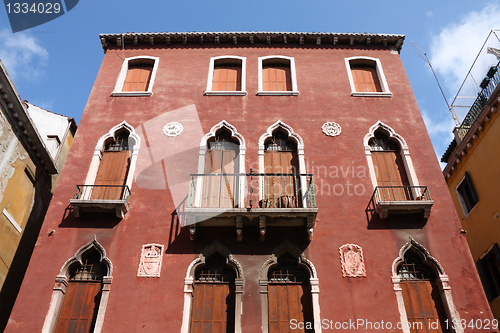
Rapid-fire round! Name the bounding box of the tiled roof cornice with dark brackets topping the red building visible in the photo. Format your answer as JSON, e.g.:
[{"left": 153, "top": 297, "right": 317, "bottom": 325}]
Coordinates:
[{"left": 99, "top": 31, "right": 405, "bottom": 52}]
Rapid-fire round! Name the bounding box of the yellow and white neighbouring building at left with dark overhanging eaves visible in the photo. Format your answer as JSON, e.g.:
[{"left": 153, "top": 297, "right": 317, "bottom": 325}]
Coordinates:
[{"left": 0, "top": 61, "right": 76, "bottom": 331}]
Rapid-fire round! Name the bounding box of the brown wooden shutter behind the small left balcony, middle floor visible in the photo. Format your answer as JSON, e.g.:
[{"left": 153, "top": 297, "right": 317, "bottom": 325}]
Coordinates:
[{"left": 92, "top": 150, "right": 130, "bottom": 200}]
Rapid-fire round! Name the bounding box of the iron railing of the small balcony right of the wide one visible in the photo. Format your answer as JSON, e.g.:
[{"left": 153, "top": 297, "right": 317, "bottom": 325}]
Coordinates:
[{"left": 373, "top": 186, "right": 432, "bottom": 203}]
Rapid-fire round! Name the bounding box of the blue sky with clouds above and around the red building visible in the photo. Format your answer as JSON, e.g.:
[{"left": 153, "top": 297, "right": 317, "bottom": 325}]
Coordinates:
[{"left": 0, "top": 0, "right": 500, "bottom": 162}]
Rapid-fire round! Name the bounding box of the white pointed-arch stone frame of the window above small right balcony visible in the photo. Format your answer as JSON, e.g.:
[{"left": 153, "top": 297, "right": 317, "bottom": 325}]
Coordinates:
[{"left": 363, "top": 120, "right": 419, "bottom": 190}]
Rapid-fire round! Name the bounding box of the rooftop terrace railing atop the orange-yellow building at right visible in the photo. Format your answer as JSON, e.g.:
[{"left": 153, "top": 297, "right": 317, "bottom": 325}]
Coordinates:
[{"left": 455, "top": 62, "right": 500, "bottom": 140}]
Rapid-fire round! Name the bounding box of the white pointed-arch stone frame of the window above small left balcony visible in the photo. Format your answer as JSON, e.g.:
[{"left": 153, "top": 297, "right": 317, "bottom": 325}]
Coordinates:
[{"left": 84, "top": 121, "right": 141, "bottom": 195}]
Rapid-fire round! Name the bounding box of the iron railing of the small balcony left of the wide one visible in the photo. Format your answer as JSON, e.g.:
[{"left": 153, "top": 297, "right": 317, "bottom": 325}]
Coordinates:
[{"left": 72, "top": 185, "right": 130, "bottom": 203}]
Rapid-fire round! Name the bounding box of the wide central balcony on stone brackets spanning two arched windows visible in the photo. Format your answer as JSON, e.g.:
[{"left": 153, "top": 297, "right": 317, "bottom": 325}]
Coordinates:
[{"left": 186, "top": 172, "right": 318, "bottom": 240}]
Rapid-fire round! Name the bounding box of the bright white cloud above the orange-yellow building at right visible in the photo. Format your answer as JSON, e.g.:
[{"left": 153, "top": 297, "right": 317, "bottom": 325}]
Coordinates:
[{"left": 430, "top": 3, "right": 500, "bottom": 94}]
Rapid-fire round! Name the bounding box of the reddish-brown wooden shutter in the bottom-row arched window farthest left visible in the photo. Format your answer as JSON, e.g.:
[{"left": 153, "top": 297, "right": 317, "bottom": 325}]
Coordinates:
[{"left": 54, "top": 281, "right": 101, "bottom": 333}]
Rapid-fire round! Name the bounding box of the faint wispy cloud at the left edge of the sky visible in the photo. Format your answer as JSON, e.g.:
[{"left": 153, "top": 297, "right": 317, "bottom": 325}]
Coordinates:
[{"left": 0, "top": 30, "right": 49, "bottom": 79}]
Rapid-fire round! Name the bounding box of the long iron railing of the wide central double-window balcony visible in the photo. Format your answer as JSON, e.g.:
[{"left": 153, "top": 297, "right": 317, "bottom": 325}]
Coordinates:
[{"left": 188, "top": 172, "right": 316, "bottom": 209}]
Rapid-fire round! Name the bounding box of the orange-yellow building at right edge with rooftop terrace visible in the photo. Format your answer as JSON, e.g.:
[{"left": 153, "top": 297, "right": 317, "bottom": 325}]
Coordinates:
[{"left": 441, "top": 46, "right": 500, "bottom": 319}]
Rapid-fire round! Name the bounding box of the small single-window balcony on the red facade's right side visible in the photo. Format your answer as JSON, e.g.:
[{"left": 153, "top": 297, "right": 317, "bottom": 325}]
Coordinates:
[{"left": 371, "top": 186, "right": 434, "bottom": 219}]
